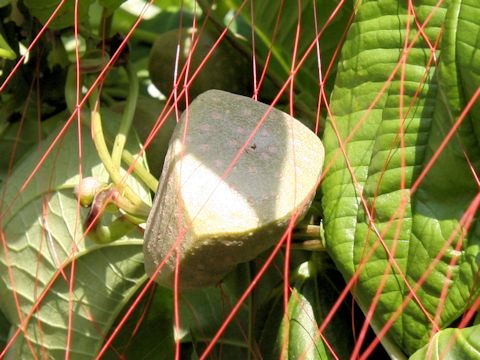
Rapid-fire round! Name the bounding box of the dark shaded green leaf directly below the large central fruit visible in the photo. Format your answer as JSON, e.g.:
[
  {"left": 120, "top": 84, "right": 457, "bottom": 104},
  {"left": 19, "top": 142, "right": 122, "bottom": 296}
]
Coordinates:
[{"left": 103, "top": 266, "right": 250, "bottom": 359}]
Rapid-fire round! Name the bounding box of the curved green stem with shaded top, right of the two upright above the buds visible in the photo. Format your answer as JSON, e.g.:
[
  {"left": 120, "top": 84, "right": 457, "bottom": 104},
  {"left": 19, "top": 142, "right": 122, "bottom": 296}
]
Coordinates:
[{"left": 112, "top": 63, "right": 138, "bottom": 168}]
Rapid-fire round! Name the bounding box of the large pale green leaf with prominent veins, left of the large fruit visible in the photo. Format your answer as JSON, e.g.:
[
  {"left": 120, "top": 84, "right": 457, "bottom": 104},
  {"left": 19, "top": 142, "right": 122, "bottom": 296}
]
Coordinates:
[{"left": 0, "top": 116, "right": 149, "bottom": 359}]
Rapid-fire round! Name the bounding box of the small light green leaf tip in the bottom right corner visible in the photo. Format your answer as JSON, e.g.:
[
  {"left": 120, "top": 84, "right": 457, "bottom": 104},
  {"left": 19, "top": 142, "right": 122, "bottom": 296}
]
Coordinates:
[{"left": 410, "top": 325, "right": 480, "bottom": 360}]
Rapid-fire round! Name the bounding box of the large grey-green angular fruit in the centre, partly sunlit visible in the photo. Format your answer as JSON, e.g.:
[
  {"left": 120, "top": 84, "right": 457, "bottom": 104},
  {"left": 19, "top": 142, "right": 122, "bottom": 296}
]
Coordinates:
[{"left": 144, "top": 90, "right": 324, "bottom": 288}]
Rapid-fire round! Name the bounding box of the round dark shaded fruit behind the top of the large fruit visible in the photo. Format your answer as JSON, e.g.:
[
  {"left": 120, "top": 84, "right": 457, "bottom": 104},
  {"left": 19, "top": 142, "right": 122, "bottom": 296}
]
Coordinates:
[{"left": 148, "top": 28, "right": 252, "bottom": 103}]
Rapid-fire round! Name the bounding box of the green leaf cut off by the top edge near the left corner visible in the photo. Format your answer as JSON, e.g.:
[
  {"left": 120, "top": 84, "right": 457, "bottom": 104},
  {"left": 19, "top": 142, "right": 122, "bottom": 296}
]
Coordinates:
[{"left": 24, "top": 0, "right": 93, "bottom": 30}]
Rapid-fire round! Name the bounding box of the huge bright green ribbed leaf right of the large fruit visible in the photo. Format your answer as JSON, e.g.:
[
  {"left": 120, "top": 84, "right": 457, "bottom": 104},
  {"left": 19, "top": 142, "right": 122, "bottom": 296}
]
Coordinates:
[{"left": 322, "top": 0, "right": 480, "bottom": 354}]
